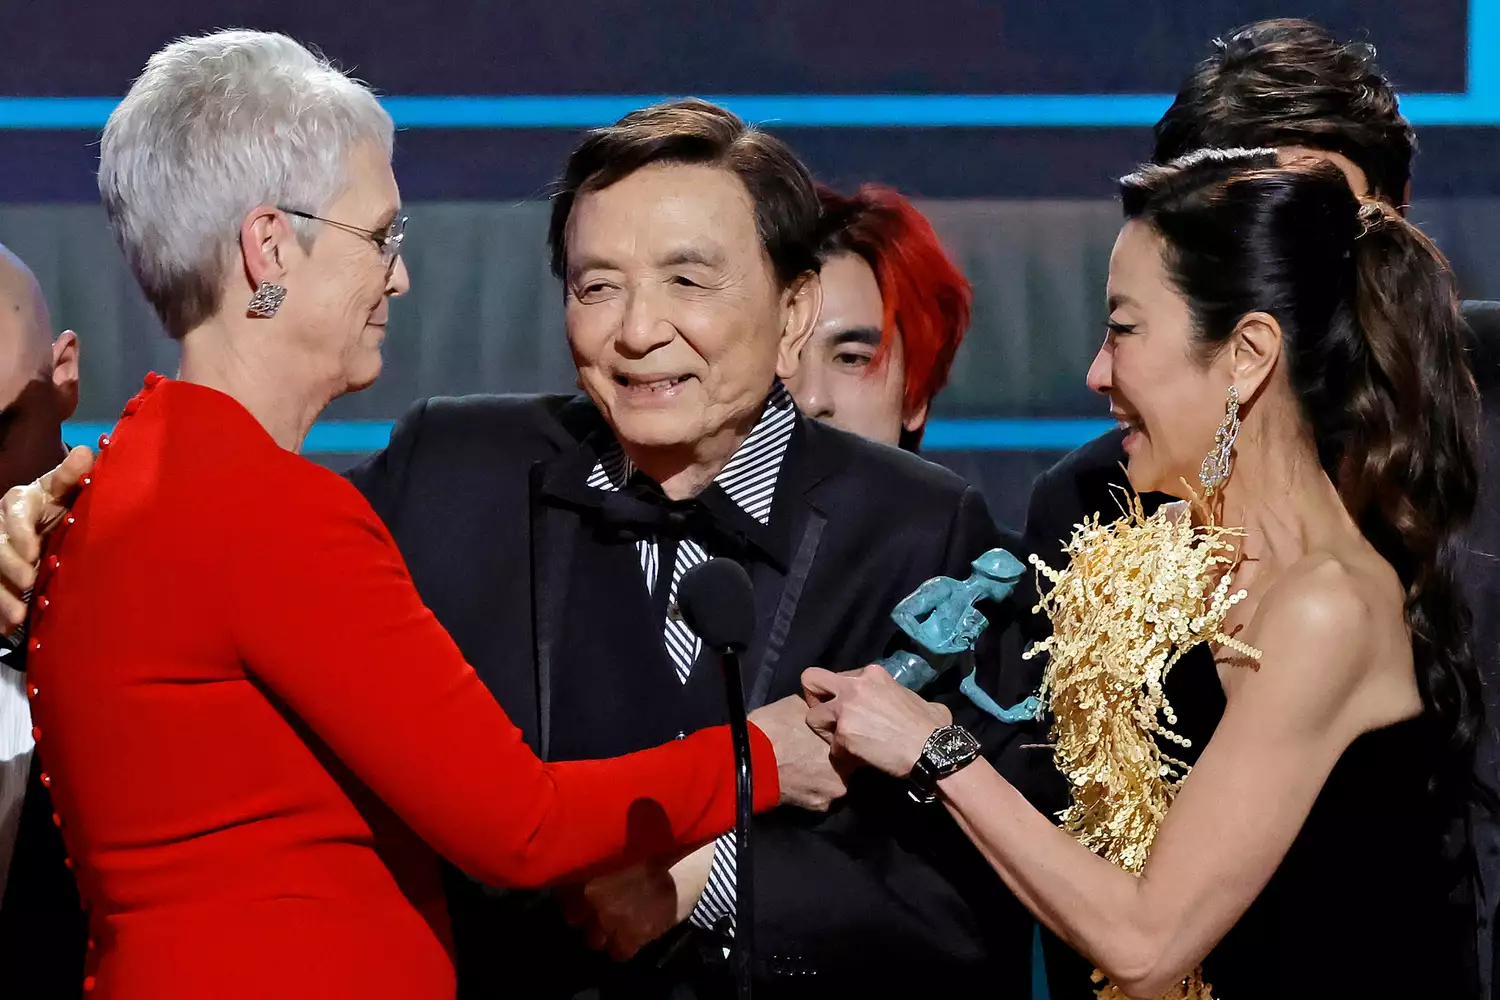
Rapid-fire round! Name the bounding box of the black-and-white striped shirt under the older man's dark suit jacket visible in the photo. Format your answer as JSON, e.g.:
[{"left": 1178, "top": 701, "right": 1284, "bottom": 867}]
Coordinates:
[{"left": 588, "top": 382, "right": 797, "bottom": 930}]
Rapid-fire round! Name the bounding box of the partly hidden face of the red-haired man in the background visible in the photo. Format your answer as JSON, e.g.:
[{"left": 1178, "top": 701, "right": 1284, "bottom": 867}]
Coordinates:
[{"left": 786, "top": 253, "right": 927, "bottom": 445}]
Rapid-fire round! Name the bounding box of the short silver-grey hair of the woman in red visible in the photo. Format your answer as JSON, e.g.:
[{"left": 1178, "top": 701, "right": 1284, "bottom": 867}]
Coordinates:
[{"left": 99, "top": 30, "right": 395, "bottom": 337}]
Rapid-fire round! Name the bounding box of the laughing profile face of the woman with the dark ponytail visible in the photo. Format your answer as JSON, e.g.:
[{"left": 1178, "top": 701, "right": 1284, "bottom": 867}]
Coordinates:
[{"left": 1088, "top": 220, "right": 1233, "bottom": 496}]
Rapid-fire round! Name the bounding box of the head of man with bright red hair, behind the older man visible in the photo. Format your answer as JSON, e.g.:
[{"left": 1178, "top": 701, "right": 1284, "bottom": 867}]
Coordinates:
[{"left": 786, "top": 184, "right": 972, "bottom": 451}]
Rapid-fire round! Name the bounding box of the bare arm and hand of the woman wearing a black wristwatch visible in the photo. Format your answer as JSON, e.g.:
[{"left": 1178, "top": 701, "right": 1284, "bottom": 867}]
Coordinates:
[{"left": 804, "top": 561, "right": 1410, "bottom": 997}]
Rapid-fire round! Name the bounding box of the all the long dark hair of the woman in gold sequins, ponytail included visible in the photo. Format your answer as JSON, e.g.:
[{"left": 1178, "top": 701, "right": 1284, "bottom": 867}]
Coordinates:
[{"left": 1121, "top": 150, "right": 1494, "bottom": 816}]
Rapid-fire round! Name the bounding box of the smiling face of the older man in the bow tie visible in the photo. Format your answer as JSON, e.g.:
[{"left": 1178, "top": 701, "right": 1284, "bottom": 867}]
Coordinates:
[{"left": 564, "top": 163, "right": 818, "bottom": 465}]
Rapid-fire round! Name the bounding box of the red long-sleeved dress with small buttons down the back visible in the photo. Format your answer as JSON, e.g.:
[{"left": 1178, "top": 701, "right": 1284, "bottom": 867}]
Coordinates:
[{"left": 27, "top": 375, "right": 779, "bottom": 1000}]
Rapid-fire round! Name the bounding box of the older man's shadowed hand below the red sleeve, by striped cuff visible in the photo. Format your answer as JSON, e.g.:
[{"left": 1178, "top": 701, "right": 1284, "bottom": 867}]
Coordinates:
[{"left": 566, "top": 843, "right": 714, "bottom": 963}]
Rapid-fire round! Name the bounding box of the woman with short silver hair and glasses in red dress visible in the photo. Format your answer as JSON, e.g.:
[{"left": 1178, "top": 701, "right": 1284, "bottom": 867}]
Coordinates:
[{"left": 27, "top": 31, "right": 779, "bottom": 1000}]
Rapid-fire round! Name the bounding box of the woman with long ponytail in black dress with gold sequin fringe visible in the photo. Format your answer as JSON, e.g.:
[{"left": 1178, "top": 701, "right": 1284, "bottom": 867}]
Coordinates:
[{"left": 804, "top": 150, "right": 1479, "bottom": 1000}]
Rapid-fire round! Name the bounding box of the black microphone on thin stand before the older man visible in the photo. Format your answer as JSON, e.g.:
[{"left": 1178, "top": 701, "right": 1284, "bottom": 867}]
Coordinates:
[{"left": 677, "top": 556, "right": 755, "bottom": 1000}]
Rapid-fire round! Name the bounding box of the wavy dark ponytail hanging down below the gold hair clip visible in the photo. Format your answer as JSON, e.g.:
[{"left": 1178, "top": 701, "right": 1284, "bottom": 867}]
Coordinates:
[{"left": 1335, "top": 201, "right": 1485, "bottom": 815}]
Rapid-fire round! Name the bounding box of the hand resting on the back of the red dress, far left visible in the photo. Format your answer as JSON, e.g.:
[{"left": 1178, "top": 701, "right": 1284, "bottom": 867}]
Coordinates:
[{"left": 0, "top": 445, "right": 93, "bottom": 636}]
